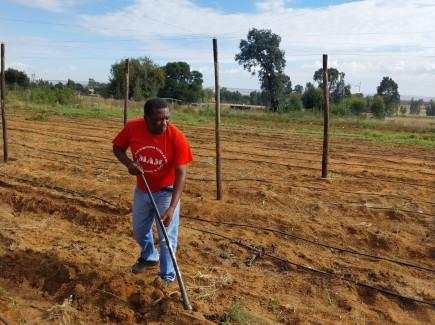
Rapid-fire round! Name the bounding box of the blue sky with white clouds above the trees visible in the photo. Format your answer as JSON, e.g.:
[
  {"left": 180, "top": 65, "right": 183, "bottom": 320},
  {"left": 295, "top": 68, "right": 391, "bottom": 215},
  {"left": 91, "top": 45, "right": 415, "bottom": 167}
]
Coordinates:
[{"left": 0, "top": 0, "right": 435, "bottom": 99}]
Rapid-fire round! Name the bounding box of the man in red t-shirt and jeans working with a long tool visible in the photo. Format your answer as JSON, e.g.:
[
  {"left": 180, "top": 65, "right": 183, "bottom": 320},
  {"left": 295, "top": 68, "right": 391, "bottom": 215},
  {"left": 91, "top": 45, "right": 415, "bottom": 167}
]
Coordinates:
[{"left": 112, "top": 98, "right": 193, "bottom": 286}]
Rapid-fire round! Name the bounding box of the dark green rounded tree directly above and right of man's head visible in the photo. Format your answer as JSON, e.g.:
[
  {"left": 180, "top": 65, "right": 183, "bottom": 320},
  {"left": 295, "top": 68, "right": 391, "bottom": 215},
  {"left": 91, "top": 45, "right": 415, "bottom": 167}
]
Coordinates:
[{"left": 159, "top": 62, "right": 203, "bottom": 102}]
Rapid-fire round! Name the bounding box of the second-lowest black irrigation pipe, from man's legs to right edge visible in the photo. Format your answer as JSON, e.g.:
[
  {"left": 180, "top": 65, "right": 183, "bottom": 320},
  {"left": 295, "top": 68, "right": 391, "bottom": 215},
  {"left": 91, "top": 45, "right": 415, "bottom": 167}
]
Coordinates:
[{"left": 182, "top": 215, "right": 435, "bottom": 273}]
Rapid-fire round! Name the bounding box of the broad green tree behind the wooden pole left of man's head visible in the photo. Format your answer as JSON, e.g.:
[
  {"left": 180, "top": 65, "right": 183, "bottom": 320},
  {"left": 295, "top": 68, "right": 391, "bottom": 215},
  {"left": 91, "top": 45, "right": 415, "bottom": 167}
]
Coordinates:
[{"left": 105, "top": 57, "right": 165, "bottom": 100}]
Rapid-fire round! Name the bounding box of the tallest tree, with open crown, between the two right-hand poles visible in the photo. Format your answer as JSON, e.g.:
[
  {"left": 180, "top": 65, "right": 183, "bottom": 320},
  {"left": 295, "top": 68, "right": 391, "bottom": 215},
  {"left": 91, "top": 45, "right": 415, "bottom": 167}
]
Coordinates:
[{"left": 235, "top": 28, "right": 291, "bottom": 112}]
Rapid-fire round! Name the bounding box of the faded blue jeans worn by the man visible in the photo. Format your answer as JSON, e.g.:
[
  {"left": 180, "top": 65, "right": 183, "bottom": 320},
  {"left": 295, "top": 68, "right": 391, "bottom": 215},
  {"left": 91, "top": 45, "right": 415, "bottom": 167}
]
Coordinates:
[{"left": 132, "top": 186, "right": 180, "bottom": 280}]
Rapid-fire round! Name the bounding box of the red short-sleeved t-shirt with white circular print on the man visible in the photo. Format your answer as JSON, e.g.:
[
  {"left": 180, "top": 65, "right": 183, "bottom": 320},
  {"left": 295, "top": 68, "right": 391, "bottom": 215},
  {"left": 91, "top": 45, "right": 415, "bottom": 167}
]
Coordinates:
[{"left": 112, "top": 117, "right": 193, "bottom": 193}]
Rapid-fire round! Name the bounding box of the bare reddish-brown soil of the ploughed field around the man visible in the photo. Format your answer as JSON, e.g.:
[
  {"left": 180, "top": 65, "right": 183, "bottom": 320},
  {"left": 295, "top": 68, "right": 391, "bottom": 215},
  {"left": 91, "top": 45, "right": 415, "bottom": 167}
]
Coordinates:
[{"left": 0, "top": 109, "right": 435, "bottom": 325}]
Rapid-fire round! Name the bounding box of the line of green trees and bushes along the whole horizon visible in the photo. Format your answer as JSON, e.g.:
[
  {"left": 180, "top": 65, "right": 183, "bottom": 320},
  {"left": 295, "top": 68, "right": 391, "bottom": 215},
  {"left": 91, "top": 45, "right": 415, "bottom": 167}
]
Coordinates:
[{"left": 5, "top": 28, "right": 435, "bottom": 119}]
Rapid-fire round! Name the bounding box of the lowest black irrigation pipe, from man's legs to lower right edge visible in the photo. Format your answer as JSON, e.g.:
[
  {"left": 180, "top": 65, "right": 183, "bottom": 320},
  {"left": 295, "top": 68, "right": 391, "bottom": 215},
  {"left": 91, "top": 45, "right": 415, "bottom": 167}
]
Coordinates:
[{"left": 183, "top": 226, "right": 435, "bottom": 306}]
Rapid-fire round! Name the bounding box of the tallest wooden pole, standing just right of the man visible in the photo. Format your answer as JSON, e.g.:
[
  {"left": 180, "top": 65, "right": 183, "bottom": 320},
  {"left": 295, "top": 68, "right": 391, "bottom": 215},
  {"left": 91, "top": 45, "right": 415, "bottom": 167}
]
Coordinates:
[{"left": 213, "top": 38, "right": 222, "bottom": 200}]
